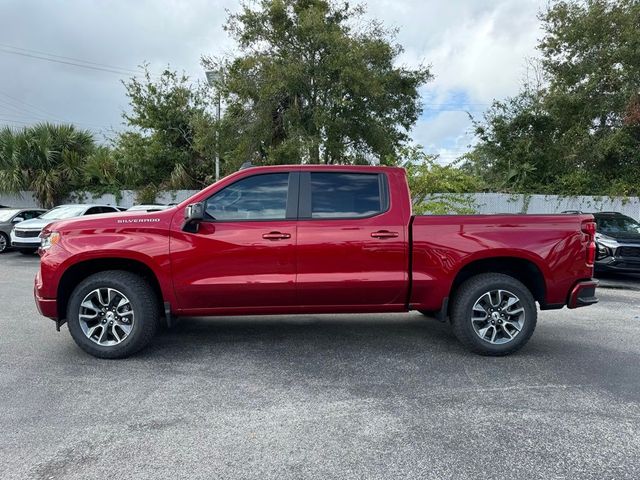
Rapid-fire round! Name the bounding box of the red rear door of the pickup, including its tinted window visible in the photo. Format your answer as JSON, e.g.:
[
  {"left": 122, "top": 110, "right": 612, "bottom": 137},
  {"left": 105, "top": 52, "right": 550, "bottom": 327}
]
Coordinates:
[{"left": 297, "top": 171, "right": 408, "bottom": 311}]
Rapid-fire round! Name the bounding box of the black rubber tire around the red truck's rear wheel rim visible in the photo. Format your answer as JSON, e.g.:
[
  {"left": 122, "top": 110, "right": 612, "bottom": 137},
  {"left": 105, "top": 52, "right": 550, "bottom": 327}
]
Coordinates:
[{"left": 451, "top": 273, "right": 538, "bottom": 356}]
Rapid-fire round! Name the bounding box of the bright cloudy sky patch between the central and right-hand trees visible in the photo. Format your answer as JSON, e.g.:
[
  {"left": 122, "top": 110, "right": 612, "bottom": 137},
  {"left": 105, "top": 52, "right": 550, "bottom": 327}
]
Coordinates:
[{"left": 368, "top": 0, "right": 544, "bottom": 163}]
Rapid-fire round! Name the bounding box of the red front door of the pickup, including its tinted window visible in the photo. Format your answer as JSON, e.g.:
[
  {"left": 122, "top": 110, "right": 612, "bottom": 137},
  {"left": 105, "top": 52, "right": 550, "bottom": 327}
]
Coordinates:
[{"left": 171, "top": 172, "right": 298, "bottom": 314}]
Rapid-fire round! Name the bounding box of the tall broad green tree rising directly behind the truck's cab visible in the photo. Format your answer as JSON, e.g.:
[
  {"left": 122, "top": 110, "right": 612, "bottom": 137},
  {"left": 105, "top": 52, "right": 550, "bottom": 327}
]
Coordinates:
[{"left": 208, "top": 0, "right": 431, "bottom": 167}]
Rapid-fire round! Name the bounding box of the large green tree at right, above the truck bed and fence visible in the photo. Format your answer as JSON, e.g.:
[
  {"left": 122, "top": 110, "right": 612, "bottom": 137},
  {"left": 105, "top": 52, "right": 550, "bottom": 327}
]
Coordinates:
[{"left": 467, "top": 0, "right": 640, "bottom": 195}]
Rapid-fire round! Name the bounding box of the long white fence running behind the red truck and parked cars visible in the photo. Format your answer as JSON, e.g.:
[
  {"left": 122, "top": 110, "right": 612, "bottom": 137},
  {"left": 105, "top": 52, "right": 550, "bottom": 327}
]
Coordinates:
[{"left": 0, "top": 190, "right": 640, "bottom": 219}]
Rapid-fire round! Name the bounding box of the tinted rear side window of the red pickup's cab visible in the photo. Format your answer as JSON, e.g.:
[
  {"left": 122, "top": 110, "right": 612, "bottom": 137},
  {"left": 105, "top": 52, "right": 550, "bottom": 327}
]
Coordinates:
[{"left": 311, "top": 172, "right": 386, "bottom": 218}]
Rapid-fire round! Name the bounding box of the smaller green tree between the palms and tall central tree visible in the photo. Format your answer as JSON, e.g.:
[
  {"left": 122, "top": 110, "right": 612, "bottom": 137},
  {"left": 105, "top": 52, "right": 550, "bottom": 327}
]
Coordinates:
[{"left": 115, "top": 70, "right": 217, "bottom": 189}]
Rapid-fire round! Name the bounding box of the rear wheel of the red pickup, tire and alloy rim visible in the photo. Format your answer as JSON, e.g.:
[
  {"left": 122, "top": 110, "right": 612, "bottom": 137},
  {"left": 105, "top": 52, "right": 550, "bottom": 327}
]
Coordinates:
[{"left": 451, "top": 273, "right": 537, "bottom": 356}]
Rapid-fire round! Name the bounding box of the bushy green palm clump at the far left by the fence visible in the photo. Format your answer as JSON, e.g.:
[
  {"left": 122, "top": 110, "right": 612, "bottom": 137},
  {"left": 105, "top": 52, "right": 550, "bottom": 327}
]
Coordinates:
[{"left": 0, "top": 123, "right": 95, "bottom": 207}]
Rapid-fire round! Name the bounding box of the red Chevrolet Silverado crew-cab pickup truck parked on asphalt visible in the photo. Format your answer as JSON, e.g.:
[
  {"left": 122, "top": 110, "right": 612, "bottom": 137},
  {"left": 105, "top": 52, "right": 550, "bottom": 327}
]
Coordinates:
[{"left": 35, "top": 165, "right": 597, "bottom": 358}]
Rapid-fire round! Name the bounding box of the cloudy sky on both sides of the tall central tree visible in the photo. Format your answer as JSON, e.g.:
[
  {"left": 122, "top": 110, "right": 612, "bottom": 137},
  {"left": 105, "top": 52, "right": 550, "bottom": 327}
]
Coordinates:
[{"left": 0, "top": 0, "right": 545, "bottom": 163}]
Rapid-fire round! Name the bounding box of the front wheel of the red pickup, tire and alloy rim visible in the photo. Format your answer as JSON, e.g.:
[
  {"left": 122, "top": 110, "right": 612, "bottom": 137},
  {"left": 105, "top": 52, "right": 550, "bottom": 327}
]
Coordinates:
[{"left": 67, "top": 270, "right": 160, "bottom": 358}]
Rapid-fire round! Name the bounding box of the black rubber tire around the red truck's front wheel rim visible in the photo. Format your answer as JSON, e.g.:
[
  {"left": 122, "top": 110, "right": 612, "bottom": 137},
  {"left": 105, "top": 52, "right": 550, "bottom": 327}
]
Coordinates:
[{"left": 67, "top": 270, "right": 161, "bottom": 358}]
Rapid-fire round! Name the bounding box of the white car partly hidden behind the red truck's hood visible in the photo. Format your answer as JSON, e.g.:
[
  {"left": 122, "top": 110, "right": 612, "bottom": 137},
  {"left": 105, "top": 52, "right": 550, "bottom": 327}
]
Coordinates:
[{"left": 11, "top": 204, "right": 120, "bottom": 254}]
